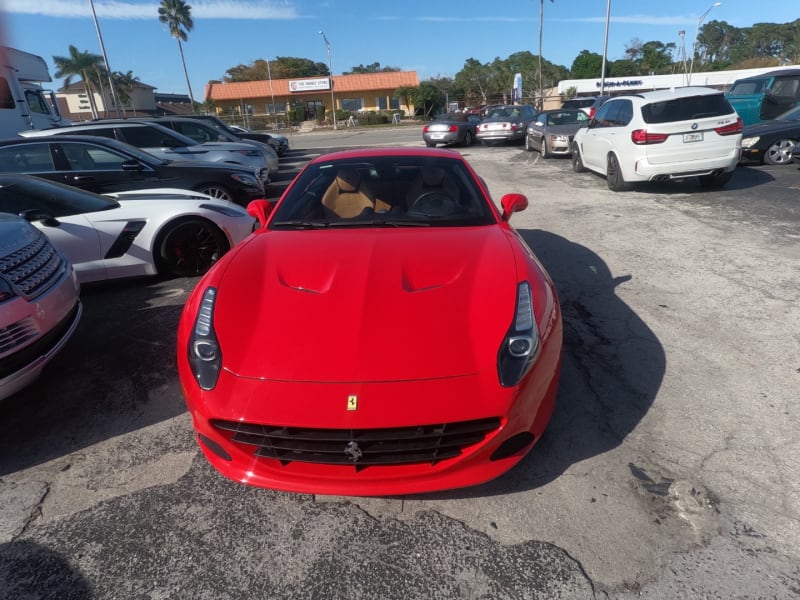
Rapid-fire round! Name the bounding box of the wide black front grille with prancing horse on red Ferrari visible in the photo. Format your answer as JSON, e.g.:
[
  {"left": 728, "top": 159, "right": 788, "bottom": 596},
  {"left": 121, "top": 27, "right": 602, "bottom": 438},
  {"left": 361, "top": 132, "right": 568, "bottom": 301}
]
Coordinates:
[{"left": 211, "top": 417, "right": 500, "bottom": 468}]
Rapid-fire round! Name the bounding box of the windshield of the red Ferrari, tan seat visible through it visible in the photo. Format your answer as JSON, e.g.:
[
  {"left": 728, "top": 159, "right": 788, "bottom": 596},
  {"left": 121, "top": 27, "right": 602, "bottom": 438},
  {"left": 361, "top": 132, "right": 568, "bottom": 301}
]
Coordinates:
[{"left": 270, "top": 156, "right": 495, "bottom": 229}]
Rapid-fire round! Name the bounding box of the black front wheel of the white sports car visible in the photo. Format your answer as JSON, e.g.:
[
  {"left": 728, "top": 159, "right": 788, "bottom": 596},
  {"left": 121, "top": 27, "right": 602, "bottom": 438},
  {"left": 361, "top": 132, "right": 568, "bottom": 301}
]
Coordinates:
[{"left": 153, "top": 217, "right": 230, "bottom": 277}]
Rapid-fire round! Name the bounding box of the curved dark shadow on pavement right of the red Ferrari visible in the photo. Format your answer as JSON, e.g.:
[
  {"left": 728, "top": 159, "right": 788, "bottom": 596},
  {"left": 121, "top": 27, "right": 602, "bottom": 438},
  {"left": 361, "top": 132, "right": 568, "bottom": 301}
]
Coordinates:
[{"left": 406, "top": 229, "right": 668, "bottom": 499}]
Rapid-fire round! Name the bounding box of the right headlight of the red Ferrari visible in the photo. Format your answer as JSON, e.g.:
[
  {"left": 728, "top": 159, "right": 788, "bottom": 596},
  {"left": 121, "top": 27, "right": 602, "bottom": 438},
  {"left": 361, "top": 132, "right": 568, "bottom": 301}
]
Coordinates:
[{"left": 497, "top": 281, "right": 539, "bottom": 387}]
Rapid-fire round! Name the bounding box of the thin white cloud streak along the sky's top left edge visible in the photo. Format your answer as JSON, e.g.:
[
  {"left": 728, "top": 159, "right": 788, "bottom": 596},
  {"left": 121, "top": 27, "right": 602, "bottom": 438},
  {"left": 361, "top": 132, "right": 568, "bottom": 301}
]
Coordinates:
[{"left": 0, "top": 0, "right": 300, "bottom": 20}]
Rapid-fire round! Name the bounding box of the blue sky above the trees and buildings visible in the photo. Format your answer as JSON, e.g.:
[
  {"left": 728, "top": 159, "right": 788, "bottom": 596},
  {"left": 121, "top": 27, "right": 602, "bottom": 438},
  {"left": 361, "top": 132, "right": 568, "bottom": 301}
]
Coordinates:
[{"left": 0, "top": 0, "right": 800, "bottom": 100}]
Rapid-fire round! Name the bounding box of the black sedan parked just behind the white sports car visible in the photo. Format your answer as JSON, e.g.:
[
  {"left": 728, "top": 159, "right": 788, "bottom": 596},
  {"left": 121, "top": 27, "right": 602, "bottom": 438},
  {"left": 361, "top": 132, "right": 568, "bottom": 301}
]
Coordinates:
[{"left": 0, "top": 135, "right": 265, "bottom": 205}]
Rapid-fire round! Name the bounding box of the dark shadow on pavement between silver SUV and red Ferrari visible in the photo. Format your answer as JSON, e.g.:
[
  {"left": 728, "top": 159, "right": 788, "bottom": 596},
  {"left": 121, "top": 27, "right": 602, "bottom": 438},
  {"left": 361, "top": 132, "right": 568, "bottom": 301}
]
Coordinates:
[{"left": 0, "top": 278, "right": 193, "bottom": 476}]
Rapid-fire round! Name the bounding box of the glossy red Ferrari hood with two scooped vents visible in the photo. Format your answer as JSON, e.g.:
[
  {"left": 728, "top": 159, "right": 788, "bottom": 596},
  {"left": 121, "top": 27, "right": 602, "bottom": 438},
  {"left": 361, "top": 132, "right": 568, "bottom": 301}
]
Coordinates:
[{"left": 214, "top": 226, "right": 517, "bottom": 382}]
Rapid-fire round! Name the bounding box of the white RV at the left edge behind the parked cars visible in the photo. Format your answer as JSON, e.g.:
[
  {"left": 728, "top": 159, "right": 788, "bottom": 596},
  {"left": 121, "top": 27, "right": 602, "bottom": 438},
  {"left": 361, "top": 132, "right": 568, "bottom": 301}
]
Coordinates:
[{"left": 0, "top": 46, "right": 69, "bottom": 138}]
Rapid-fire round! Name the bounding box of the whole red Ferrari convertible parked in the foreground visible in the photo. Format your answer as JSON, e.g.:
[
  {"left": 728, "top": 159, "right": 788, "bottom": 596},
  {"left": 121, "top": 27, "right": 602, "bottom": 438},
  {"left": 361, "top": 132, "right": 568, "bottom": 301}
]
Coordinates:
[{"left": 178, "top": 148, "right": 562, "bottom": 496}]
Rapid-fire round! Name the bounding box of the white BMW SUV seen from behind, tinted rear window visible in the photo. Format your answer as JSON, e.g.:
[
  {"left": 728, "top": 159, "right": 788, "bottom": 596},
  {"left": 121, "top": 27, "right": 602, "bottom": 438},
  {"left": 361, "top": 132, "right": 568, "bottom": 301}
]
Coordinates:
[{"left": 572, "top": 87, "right": 742, "bottom": 191}]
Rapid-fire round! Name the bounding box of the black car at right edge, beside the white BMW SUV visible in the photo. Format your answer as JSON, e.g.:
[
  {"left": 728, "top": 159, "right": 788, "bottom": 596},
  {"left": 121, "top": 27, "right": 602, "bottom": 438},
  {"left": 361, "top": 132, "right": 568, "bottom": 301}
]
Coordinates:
[{"left": 742, "top": 106, "right": 800, "bottom": 165}]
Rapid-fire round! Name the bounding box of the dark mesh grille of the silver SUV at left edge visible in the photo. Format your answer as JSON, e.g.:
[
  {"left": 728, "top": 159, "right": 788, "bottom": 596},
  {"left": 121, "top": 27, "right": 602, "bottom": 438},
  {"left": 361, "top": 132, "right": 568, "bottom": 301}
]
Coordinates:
[{"left": 0, "top": 232, "right": 67, "bottom": 298}]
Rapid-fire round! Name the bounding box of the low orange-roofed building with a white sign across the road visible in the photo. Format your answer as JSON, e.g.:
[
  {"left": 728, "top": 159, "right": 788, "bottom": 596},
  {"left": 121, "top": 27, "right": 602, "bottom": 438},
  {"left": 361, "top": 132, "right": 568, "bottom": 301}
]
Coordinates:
[{"left": 205, "top": 71, "right": 419, "bottom": 119}]
